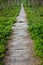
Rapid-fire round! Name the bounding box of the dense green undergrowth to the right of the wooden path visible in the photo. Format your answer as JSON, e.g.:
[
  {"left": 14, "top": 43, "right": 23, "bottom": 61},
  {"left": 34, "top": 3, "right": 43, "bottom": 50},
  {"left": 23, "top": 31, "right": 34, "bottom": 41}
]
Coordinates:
[{"left": 25, "top": 6, "right": 43, "bottom": 65}]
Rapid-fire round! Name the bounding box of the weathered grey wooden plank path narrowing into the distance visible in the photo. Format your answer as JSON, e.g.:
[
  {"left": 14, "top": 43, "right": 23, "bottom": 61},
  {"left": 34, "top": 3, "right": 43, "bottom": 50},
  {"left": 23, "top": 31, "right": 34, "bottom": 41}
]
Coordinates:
[{"left": 4, "top": 6, "right": 38, "bottom": 65}]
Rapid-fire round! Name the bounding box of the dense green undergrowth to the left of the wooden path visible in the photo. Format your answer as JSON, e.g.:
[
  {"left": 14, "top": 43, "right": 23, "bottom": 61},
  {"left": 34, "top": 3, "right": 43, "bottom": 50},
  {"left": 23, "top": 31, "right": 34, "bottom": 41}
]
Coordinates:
[{"left": 0, "top": 0, "right": 20, "bottom": 65}]
